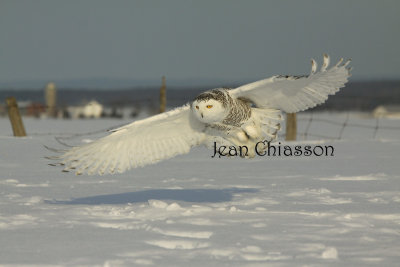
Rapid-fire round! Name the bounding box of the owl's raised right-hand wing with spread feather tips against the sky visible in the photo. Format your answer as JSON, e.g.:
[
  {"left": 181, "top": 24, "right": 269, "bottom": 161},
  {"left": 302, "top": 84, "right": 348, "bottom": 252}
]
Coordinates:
[{"left": 230, "top": 54, "right": 351, "bottom": 113}]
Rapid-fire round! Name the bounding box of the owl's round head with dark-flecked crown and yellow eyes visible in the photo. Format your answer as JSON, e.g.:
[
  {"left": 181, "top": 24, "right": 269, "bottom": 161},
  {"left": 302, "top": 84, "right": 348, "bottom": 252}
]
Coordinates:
[{"left": 192, "top": 90, "right": 229, "bottom": 123}]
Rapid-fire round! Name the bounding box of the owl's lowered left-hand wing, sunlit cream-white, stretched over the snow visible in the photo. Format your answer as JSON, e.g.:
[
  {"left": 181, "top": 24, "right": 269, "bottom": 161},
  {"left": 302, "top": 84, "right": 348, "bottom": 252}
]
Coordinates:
[{"left": 51, "top": 105, "right": 204, "bottom": 175}]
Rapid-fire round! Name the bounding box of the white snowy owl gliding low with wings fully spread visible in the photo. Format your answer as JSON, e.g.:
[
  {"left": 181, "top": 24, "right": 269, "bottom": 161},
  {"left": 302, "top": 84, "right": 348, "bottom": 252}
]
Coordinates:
[{"left": 50, "top": 54, "right": 350, "bottom": 175}]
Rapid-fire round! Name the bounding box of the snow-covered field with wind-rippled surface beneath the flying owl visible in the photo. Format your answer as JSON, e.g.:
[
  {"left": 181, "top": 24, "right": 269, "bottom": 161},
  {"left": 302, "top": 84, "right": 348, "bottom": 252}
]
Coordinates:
[{"left": 0, "top": 113, "right": 400, "bottom": 266}]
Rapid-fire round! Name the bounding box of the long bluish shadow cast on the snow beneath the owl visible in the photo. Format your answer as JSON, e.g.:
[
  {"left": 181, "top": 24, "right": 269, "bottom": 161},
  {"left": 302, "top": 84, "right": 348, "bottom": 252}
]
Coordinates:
[{"left": 45, "top": 188, "right": 258, "bottom": 205}]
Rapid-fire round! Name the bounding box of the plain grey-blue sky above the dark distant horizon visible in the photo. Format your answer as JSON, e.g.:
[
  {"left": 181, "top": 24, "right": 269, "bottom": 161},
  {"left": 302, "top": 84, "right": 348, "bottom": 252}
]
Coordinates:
[{"left": 0, "top": 0, "right": 400, "bottom": 88}]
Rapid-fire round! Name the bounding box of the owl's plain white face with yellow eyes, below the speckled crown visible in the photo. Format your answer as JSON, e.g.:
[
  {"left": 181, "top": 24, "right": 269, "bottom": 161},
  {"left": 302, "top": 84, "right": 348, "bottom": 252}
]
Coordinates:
[{"left": 192, "top": 99, "right": 228, "bottom": 123}]
